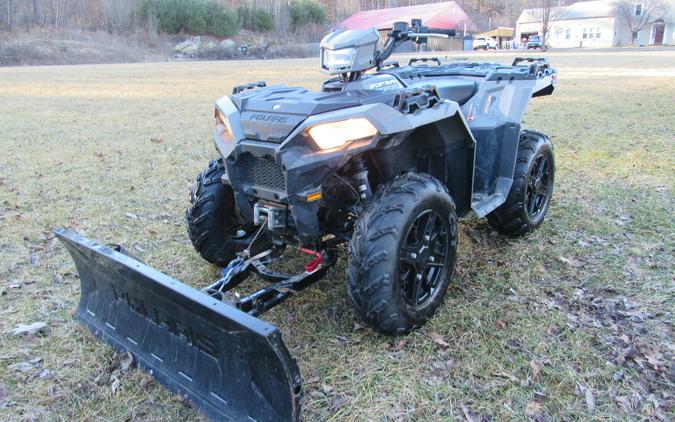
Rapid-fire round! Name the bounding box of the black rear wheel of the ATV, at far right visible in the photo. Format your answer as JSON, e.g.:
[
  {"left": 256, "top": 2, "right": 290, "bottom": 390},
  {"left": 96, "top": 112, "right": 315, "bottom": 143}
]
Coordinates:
[{"left": 487, "top": 131, "right": 555, "bottom": 236}]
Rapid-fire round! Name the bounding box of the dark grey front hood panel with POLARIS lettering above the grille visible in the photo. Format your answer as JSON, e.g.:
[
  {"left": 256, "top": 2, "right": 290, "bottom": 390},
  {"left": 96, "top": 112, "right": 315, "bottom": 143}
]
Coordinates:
[{"left": 231, "top": 86, "right": 386, "bottom": 142}]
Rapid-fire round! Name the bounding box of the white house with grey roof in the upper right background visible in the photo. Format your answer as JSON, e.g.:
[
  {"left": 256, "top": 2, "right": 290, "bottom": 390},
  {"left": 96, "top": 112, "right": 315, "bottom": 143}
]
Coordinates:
[{"left": 516, "top": 0, "right": 675, "bottom": 48}]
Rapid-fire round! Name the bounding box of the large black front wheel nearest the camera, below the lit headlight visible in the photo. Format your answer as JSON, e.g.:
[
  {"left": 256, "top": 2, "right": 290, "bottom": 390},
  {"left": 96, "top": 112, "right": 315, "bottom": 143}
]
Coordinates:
[{"left": 347, "top": 173, "right": 457, "bottom": 335}]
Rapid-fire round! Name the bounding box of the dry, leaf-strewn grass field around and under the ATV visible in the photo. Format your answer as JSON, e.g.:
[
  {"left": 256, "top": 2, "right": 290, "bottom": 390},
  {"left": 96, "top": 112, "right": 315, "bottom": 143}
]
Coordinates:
[{"left": 0, "top": 50, "right": 675, "bottom": 421}]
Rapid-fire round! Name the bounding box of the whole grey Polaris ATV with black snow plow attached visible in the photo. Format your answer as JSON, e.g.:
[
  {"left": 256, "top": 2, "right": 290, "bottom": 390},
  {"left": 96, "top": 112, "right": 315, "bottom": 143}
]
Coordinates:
[{"left": 57, "top": 21, "right": 556, "bottom": 421}]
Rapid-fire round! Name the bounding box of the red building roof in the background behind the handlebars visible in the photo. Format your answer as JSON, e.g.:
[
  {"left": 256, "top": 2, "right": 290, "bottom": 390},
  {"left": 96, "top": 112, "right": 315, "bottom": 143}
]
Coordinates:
[{"left": 339, "top": 1, "right": 476, "bottom": 31}]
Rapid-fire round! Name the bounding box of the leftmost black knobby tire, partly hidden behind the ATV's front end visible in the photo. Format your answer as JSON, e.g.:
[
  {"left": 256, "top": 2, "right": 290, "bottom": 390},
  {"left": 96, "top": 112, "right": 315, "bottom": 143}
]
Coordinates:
[{"left": 185, "top": 159, "right": 246, "bottom": 266}]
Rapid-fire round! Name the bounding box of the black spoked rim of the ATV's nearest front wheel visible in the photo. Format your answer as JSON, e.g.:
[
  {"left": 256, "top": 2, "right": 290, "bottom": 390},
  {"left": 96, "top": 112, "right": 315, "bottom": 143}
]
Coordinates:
[{"left": 399, "top": 210, "right": 449, "bottom": 306}]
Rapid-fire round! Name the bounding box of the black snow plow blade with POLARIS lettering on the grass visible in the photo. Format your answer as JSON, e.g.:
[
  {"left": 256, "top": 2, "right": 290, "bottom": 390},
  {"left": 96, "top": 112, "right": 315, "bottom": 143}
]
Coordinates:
[{"left": 55, "top": 229, "right": 303, "bottom": 422}]
